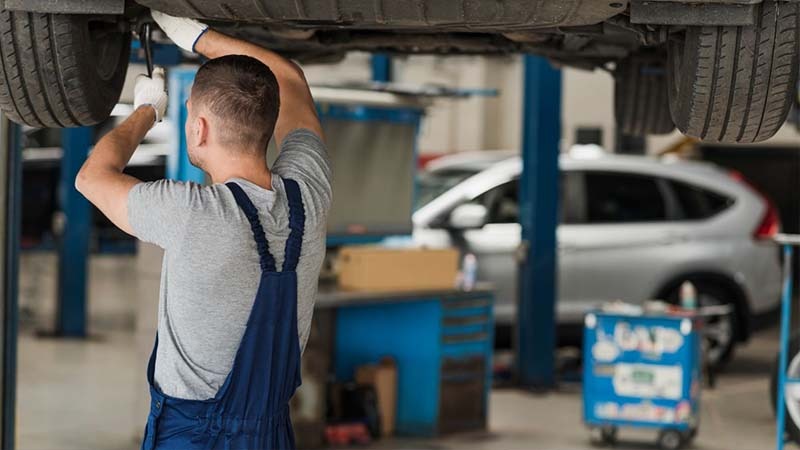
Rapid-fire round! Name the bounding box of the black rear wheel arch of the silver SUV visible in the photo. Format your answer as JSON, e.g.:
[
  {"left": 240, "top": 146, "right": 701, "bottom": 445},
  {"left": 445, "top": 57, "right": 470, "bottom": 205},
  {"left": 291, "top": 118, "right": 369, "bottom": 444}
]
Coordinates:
[{"left": 652, "top": 270, "right": 751, "bottom": 342}]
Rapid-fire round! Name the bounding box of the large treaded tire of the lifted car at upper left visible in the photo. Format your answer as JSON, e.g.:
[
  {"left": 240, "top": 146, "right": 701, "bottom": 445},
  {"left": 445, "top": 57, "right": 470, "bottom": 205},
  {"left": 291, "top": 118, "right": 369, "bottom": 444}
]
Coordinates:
[{"left": 0, "top": 10, "right": 131, "bottom": 128}]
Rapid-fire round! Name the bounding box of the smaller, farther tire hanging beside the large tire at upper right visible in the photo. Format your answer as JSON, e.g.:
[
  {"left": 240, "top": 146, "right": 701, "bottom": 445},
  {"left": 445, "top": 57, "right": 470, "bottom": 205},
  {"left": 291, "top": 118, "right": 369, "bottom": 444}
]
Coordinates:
[{"left": 614, "top": 55, "right": 675, "bottom": 136}]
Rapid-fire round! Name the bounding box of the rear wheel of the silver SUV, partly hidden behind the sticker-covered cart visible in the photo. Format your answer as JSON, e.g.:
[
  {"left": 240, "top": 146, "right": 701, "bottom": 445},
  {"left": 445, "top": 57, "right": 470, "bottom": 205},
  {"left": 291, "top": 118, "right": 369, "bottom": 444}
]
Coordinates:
[{"left": 670, "top": 280, "right": 738, "bottom": 370}]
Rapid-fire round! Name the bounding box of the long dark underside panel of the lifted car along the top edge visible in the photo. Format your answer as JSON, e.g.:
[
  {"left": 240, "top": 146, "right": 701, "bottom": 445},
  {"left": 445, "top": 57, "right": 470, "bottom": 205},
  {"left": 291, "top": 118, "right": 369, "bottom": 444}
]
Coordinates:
[{"left": 138, "top": 0, "right": 628, "bottom": 32}]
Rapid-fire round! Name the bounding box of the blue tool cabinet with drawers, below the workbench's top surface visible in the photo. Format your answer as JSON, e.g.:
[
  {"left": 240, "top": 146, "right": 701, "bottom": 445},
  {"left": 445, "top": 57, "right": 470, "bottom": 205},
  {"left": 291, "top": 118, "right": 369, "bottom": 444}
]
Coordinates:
[{"left": 333, "top": 290, "right": 494, "bottom": 436}]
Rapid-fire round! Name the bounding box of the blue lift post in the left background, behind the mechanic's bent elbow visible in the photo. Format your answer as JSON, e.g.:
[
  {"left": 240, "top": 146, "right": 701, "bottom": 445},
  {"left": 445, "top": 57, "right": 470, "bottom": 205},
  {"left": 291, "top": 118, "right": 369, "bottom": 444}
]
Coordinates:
[{"left": 55, "top": 127, "right": 94, "bottom": 337}]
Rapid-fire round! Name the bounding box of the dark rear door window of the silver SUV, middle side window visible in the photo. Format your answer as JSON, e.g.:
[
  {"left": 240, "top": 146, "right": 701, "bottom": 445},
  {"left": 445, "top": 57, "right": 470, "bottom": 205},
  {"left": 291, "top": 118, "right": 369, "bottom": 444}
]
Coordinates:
[{"left": 584, "top": 171, "right": 667, "bottom": 224}]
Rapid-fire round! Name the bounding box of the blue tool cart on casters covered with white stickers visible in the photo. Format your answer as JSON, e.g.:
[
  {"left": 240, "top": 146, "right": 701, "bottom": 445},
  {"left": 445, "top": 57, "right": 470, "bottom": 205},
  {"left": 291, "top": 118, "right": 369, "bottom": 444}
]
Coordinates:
[{"left": 583, "top": 311, "right": 702, "bottom": 450}]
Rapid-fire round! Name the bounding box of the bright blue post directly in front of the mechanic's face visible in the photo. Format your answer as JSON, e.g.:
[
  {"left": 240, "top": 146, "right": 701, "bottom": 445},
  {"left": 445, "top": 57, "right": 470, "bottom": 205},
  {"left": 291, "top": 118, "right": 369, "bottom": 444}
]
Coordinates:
[{"left": 167, "top": 67, "right": 206, "bottom": 184}]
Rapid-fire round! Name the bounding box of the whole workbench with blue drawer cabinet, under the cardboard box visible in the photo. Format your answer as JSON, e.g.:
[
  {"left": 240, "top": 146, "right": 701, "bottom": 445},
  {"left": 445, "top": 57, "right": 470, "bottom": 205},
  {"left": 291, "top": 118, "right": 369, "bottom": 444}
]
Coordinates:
[{"left": 292, "top": 284, "right": 494, "bottom": 445}]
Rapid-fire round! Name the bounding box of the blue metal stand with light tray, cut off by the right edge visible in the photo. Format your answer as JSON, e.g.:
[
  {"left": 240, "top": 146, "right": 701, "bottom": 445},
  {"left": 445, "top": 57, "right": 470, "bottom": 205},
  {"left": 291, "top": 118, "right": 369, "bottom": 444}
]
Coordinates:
[{"left": 773, "top": 234, "right": 800, "bottom": 450}]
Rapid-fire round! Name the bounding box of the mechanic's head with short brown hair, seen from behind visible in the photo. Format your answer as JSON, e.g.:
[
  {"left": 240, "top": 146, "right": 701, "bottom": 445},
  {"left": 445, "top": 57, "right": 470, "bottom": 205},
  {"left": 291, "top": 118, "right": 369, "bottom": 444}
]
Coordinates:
[{"left": 191, "top": 55, "right": 280, "bottom": 151}]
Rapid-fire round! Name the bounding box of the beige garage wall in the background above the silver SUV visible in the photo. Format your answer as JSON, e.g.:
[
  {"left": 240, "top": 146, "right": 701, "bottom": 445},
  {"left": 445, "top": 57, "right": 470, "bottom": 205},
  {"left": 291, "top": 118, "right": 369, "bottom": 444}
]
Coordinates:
[{"left": 304, "top": 53, "right": 614, "bottom": 153}]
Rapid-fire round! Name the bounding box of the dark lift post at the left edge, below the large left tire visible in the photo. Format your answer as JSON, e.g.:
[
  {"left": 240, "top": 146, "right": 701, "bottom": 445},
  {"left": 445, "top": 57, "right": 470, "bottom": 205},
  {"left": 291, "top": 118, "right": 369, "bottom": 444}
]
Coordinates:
[{"left": 0, "top": 117, "right": 22, "bottom": 449}]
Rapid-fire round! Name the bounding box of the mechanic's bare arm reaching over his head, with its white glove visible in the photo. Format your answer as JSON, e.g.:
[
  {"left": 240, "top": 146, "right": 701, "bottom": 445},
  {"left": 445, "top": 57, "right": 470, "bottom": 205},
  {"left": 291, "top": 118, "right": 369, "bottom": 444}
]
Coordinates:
[{"left": 152, "top": 11, "right": 322, "bottom": 145}]
